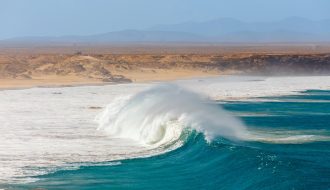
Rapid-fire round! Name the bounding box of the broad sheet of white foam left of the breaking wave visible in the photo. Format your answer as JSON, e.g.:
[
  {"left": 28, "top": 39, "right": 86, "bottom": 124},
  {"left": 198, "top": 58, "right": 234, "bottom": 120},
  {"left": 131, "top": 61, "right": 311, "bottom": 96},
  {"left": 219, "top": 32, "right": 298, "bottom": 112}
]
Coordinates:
[{"left": 0, "top": 84, "right": 150, "bottom": 184}]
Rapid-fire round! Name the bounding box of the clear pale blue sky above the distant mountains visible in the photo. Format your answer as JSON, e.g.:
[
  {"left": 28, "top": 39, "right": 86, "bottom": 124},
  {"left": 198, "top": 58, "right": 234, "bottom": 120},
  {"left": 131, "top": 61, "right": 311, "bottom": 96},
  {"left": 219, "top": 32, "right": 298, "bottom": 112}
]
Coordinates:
[{"left": 0, "top": 0, "right": 330, "bottom": 39}]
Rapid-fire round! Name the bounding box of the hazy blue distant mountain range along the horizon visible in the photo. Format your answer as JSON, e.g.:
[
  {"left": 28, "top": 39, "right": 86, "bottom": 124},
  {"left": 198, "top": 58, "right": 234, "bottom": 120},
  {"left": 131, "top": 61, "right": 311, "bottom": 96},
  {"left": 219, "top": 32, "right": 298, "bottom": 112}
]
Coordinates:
[{"left": 3, "top": 17, "right": 330, "bottom": 43}]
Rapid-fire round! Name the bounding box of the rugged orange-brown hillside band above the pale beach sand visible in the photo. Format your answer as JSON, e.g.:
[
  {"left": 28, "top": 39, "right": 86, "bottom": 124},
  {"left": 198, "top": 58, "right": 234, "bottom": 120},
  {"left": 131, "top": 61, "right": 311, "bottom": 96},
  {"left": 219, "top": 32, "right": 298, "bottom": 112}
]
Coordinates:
[{"left": 0, "top": 54, "right": 330, "bottom": 82}]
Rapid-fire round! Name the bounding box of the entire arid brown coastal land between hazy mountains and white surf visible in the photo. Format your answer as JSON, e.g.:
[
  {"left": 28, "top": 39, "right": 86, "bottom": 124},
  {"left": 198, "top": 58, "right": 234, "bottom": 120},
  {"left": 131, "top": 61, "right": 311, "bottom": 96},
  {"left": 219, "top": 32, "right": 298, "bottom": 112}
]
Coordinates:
[{"left": 0, "top": 43, "right": 330, "bottom": 88}]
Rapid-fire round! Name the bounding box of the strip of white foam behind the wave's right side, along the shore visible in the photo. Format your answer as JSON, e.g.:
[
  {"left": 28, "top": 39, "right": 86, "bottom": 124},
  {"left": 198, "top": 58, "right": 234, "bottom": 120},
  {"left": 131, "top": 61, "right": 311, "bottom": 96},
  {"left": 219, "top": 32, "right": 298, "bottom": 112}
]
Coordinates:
[{"left": 177, "top": 76, "right": 330, "bottom": 100}]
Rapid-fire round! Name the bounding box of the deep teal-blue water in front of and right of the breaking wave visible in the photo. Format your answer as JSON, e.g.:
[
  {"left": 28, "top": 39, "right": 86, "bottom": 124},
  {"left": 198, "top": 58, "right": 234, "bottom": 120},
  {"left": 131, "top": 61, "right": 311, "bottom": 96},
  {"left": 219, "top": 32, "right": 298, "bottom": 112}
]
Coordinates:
[{"left": 7, "top": 90, "right": 330, "bottom": 190}]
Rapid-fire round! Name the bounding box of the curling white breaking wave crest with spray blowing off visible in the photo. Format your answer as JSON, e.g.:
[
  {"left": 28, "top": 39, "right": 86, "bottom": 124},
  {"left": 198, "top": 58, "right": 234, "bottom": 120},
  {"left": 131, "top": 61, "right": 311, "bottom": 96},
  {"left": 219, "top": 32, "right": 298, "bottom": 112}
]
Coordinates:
[{"left": 97, "top": 84, "right": 247, "bottom": 146}]
